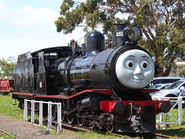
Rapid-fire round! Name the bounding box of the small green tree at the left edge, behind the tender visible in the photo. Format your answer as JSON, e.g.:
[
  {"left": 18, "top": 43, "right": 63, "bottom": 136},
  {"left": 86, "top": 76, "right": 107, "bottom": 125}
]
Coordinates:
[{"left": 0, "top": 58, "right": 15, "bottom": 79}]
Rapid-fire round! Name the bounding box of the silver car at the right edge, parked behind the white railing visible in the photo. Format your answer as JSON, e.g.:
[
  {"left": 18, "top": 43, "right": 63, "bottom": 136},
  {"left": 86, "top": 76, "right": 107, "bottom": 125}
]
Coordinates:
[{"left": 151, "top": 79, "right": 185, "bottom": 99}]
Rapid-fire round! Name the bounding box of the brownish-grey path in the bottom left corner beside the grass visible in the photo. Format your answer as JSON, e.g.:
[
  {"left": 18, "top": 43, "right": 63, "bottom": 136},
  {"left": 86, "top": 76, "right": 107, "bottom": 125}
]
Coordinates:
[{"left": 0, "top": 115, "right": 78, "bottom": 139}]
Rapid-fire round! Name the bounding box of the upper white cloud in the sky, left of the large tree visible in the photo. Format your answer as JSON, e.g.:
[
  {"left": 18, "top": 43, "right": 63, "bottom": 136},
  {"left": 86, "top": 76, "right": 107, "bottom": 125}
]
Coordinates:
[{"left": 0, "top": 0, "right": 59, "bottom": 26}]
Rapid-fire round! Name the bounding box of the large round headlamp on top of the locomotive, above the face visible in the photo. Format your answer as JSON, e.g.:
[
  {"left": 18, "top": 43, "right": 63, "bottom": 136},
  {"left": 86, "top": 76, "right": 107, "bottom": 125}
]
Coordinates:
[{"left": 124, "top": 26, "right": 141, "bottom": 42}]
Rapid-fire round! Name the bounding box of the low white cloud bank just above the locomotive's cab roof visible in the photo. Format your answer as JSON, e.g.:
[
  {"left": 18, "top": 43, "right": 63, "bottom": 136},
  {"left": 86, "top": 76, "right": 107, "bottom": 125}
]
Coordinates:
[{"left": 0, "top": 25, "right": 84, "bottom": 58}]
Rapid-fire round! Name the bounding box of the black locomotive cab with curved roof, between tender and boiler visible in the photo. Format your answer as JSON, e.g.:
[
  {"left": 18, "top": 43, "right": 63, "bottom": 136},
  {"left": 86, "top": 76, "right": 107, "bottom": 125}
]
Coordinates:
[{"left": 33, "top": 47, "right": 72, "bottom": 95}]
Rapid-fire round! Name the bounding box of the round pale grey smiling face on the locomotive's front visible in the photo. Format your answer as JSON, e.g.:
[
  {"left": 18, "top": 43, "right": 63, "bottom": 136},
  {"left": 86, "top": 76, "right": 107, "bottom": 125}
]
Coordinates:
[{"left": 115, "top": 49, "right": 154, "bottom": 89}]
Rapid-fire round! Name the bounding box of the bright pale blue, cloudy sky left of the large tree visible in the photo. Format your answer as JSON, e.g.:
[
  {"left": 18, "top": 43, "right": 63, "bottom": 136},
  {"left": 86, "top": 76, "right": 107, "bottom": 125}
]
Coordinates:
[{"left": 0, "top": 0, "right": 84, "bottom": 58}]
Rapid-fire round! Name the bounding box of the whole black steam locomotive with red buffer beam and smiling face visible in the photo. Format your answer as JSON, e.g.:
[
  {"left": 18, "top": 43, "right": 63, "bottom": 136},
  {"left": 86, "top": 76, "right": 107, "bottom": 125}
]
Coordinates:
[{"left": 12, "top": 24, "right": 169, "bottom": 135}]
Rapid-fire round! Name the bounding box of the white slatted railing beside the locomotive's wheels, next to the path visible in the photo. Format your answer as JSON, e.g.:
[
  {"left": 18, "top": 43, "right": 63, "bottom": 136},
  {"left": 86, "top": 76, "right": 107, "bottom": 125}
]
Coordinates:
[{"left": 24, "top": 99, "right": 62, "bottom": 132}]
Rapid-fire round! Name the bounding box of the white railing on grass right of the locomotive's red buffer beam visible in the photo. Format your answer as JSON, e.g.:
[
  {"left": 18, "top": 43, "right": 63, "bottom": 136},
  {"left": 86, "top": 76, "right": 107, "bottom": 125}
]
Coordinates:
[{"left": 155, "top": 97, "right": 183, "bottom": 128}]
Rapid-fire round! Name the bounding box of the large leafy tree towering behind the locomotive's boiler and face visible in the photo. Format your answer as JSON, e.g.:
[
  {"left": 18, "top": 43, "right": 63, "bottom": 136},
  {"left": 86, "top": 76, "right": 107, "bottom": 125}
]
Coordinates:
[{"left": 55, "top": 0, "right": 185, "bottom": 76}]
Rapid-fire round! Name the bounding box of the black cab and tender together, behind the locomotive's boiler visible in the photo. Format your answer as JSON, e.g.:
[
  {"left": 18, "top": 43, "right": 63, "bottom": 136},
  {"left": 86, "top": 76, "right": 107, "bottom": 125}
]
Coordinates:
[{"left": 14, "top": 46, "right": 72, "bottom": 95}]
